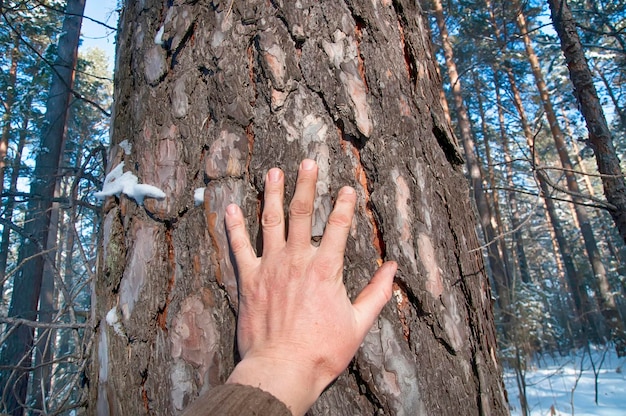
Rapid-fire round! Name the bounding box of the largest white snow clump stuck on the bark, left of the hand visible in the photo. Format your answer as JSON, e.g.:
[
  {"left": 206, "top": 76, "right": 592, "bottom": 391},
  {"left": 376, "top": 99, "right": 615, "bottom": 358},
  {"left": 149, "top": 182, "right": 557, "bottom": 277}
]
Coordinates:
[{"left": 94, "top": 162, "right": 165, "bottom": 205}]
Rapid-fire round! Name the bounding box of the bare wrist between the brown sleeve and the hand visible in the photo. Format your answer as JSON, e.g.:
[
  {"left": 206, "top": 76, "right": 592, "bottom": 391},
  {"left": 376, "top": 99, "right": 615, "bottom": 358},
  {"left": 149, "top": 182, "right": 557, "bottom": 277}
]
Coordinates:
[{"left": 226, "top": 357, "right": 326, "bottom": 416}]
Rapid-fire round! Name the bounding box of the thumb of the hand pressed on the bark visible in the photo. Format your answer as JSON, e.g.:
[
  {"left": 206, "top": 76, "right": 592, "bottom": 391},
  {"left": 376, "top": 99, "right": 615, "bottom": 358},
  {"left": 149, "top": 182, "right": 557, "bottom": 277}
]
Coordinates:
[{"left": 352, "top": 261, "right": 398, "bottom": 338}]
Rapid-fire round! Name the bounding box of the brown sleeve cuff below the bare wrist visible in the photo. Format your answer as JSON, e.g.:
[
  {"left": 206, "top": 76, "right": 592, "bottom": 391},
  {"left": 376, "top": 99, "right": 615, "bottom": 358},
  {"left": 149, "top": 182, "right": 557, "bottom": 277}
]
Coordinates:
[{"left": 182, "top": 384, "right": 293, "bottom": 416}]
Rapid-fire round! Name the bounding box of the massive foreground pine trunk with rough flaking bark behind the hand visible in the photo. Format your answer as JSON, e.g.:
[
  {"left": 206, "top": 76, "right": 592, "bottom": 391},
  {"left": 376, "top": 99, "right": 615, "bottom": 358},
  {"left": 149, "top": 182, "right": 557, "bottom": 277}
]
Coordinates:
[{"left": 89, "top": 0, "right": 508, "bottom": 415}]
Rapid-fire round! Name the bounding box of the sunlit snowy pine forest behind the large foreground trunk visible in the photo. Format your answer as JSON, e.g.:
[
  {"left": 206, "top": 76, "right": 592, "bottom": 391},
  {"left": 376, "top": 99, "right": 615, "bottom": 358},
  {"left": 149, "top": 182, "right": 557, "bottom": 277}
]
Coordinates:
[{"left": 0, "top": 0, "right": 626, "bottom": 414}]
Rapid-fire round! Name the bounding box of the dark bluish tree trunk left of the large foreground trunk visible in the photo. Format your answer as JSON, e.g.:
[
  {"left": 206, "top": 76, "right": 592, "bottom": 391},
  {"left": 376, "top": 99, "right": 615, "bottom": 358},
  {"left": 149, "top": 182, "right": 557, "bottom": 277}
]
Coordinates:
[{"left": 0, "top": 0, "right": 85, "bottom": 415}]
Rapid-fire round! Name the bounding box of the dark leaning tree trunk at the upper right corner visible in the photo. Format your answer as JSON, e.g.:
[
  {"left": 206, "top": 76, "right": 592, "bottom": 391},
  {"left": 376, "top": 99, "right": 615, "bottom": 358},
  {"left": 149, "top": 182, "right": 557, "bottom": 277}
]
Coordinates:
[{"left": 548, "top": 0, "right": 626, "bottom": 247}]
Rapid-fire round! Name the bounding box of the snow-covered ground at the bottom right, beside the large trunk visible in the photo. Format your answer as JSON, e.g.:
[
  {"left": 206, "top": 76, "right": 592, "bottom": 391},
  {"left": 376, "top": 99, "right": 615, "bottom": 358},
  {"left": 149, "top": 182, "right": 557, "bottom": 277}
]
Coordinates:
[{"left": 504, "top": 347, "right": 626, "bottom": 416}]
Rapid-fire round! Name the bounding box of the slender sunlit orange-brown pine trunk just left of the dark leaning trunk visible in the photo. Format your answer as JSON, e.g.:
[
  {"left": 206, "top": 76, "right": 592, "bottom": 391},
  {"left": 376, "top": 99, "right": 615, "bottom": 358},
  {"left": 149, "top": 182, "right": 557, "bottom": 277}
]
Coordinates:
[{"left": 517, "top": 3, "right": 626, "bottom": 356}]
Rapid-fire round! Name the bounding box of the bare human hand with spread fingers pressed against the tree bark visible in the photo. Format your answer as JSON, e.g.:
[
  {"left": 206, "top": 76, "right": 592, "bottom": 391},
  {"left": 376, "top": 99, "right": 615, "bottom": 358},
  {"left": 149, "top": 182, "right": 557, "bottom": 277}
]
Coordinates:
[{"left": 225, "top": 160, "right": 397, "bottom": 415}]
